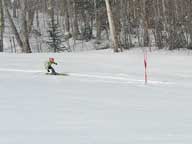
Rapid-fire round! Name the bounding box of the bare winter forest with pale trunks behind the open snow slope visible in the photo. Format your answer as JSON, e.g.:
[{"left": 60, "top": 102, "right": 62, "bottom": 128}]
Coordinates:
[{"left": 0, "top": 0, "right": 192, "bottom": 53}]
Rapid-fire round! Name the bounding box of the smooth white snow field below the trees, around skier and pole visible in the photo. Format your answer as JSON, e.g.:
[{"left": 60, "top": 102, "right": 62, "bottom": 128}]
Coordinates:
[{"left": 0, "top": 51, "right": 192, "bottom": 144}]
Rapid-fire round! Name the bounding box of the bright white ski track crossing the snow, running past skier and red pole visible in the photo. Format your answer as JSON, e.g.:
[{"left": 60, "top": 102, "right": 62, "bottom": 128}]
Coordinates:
[{"left": 0, "top": 68, "right": 175, "bottom": 85}]
